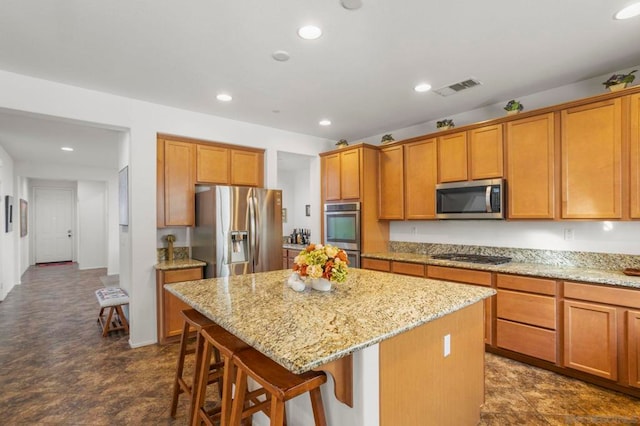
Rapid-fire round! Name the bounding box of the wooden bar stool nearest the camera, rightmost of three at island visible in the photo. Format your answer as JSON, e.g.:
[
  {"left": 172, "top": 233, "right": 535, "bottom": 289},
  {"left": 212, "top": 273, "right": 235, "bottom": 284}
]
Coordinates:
[{"left": 230, "top": 348, "right": 327, "bottom": 426}]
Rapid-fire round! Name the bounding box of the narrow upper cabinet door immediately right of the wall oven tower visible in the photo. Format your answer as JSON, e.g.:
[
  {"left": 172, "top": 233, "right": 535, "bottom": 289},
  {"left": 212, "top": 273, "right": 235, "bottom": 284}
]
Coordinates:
[{"left": 378, "top": 145, "right": 404, "bottom": 219}]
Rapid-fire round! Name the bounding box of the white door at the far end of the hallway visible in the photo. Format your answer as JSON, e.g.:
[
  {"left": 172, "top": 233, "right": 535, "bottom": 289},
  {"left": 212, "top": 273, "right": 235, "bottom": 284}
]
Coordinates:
[{"left": 34, "top": 188, "right": 73, "bottom": 263}]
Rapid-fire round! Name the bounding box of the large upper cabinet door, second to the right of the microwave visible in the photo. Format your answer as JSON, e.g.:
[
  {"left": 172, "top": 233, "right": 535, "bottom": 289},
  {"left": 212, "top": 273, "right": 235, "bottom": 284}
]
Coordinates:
[{"left": 562, "top": 98, "right": 622, "bottom": 219}]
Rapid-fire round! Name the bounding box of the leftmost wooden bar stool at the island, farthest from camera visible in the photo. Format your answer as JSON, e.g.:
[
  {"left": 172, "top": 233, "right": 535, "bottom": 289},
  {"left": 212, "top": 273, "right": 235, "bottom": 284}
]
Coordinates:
[{"left": 171, "top": 309, "right": 222, "bottom": 421}]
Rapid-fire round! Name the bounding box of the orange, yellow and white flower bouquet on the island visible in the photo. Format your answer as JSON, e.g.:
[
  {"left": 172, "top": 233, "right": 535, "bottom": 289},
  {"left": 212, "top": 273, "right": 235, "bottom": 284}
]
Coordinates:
[{"left": 293, "top": 244, "right": 349, "bottom": 283}]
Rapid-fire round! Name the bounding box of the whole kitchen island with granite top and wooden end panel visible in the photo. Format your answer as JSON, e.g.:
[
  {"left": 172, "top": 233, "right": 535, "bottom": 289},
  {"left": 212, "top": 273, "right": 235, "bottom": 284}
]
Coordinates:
[{"left": 165, "top": 269, "right": 495, "bottom": 426}]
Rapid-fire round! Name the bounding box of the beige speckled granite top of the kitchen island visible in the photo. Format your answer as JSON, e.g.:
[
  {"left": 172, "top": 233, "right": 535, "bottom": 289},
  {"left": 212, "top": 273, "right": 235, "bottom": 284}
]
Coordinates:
[{"left": 165, "top": 268, "right": 495, "bottom": 373}]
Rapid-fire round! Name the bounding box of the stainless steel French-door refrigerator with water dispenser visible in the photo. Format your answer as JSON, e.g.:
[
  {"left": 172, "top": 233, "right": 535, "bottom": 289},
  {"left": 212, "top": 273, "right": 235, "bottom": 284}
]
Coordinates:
[{"left": 191, "top": 185, "right": 282, "bottom": 278}]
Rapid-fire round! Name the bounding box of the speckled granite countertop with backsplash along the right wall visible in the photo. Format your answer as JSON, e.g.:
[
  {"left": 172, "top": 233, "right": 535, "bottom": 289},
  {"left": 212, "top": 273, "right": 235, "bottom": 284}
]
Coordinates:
[{"left": 362, "top": 242, "right": 640, "bottom": 288}]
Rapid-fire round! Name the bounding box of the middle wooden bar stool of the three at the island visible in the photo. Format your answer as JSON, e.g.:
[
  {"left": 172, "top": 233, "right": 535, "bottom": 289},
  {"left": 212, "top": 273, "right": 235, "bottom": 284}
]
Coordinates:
[{"left": 191, "top": 325, "right": 250, "bottom": 426}]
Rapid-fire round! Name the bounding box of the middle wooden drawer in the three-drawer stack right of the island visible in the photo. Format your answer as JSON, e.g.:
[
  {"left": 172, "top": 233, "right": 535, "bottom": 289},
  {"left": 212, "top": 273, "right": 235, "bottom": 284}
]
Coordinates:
[{"left": 497, "top": 290, "right": 556, "bottom": 330}]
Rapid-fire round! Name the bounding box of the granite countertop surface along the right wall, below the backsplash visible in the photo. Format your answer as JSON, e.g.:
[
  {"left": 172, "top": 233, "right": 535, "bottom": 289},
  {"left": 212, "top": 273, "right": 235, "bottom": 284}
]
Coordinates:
[{"left": 361, "top": 252, "right": 640, "bottom": 288}]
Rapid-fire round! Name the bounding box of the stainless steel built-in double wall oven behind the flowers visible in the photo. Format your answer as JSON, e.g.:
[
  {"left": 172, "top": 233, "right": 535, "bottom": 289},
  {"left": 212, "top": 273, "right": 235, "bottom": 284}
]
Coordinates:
[{"left": 324, "top": 201, "right": 360, "bottom": 268}]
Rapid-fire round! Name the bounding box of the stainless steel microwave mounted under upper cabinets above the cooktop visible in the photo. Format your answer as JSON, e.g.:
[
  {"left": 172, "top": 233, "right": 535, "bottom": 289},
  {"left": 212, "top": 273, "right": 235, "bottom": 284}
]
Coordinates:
[{"left": 436, "top": 179, "right": 506, "bottom": 219}]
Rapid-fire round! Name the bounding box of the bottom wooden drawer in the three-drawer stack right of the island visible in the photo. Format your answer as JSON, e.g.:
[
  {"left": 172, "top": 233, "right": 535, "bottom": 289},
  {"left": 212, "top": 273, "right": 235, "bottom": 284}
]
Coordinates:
[{"left": 496, "top": 319, "right": 556, "bottom": 362}]
